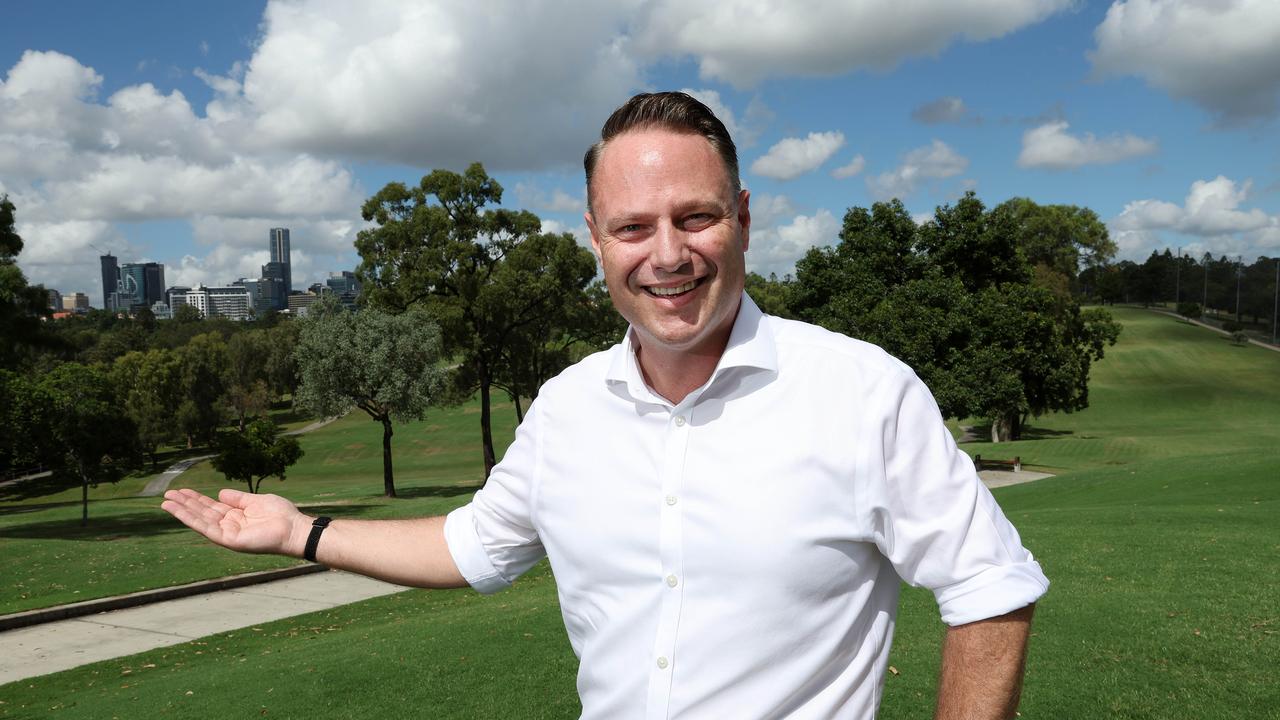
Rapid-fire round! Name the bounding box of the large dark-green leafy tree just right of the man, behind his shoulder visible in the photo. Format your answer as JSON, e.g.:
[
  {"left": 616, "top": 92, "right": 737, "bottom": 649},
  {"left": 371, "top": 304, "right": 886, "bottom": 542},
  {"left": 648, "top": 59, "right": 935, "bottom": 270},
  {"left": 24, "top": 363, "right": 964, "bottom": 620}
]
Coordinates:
[{"left": 791, "top": 193, "right": 1119, "bottom": 442}]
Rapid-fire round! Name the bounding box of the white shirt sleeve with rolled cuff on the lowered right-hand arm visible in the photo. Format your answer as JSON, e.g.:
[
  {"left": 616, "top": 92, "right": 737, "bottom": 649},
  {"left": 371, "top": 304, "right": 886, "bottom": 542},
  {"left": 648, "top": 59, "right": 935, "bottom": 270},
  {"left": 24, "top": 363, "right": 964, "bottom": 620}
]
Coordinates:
[{"left": 865, "top": 372, "right": 1048, "bottom": 625}]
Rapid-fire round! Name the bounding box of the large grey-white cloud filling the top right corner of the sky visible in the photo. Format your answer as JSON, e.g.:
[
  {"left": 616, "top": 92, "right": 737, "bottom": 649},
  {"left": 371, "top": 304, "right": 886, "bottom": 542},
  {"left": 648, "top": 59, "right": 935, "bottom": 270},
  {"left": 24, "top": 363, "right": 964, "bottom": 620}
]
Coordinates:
[{"left": 1089, "top": 0, "right": 1280, "bottom": 124}]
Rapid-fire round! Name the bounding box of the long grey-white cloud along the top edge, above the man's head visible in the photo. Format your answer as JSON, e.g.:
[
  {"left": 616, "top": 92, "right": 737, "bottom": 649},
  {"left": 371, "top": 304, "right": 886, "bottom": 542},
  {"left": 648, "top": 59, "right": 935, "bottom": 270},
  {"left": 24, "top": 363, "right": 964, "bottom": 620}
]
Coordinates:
[{"left": 635, "top": 0, "right": 1074, "bottom": 87}]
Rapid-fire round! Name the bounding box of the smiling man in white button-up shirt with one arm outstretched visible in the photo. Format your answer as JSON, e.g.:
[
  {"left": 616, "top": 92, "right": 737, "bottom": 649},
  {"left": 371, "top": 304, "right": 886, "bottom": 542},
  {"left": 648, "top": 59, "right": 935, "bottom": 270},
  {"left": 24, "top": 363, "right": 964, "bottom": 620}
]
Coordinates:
[{"left": 164, "top": 94, "right": 1048, "bottom": 719}]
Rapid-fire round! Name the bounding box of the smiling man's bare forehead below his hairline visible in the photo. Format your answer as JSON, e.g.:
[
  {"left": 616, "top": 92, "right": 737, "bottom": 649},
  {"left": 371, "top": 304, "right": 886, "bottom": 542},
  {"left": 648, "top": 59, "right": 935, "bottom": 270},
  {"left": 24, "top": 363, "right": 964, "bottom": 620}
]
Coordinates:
[{"left": 591, "top": 128, "right": 733, "bottom": 210}]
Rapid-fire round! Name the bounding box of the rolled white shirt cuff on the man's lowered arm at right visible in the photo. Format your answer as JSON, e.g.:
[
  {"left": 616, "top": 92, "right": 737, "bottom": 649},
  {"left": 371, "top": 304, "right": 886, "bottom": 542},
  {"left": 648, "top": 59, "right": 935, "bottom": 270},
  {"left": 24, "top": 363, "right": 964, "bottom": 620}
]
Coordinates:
[{"left": 936, "top": 560, "right": 1048, "bottom": 625}]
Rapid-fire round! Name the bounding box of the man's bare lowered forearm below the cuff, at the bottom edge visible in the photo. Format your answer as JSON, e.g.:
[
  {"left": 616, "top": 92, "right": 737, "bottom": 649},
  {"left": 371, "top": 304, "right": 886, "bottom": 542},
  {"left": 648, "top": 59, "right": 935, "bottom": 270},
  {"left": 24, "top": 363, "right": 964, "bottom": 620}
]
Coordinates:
[{"left": 934, "top": 605, "right": 1036, "bottom": 720}]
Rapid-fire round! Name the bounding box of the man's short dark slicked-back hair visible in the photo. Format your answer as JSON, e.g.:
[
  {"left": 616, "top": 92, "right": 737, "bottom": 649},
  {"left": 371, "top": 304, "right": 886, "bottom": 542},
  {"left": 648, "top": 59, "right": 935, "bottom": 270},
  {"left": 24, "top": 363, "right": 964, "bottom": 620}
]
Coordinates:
[{"left": 582, "top": 92, "right": 742, "bottom": 211}]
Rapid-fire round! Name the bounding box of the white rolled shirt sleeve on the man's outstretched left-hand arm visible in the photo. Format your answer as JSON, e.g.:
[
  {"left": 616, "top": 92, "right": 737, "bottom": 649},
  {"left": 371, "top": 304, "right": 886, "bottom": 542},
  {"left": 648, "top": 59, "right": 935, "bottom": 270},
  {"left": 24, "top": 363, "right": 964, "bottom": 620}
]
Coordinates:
[{"left": 444, "top": 401, "right": 547, "bottom": 594}]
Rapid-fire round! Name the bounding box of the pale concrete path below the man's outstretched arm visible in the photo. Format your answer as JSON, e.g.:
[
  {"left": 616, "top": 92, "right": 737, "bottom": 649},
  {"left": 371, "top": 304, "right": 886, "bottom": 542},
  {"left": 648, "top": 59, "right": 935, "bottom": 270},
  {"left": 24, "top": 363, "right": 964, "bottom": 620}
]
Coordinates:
[{"left": 0, "top": 570, "right": 406, "bottom": 684}]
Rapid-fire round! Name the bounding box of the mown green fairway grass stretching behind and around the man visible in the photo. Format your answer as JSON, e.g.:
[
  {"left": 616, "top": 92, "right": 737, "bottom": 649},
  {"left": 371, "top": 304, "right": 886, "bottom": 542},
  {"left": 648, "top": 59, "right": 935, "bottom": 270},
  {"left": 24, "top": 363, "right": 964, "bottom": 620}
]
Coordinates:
[{"left": 0, "top": 309, "right": 1280, "bottom": 720}]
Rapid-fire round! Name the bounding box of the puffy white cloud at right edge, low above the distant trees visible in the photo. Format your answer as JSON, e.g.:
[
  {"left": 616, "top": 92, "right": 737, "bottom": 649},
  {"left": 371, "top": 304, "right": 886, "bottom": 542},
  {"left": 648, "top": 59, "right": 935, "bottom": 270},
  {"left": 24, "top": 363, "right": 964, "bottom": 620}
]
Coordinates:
[{"left": 1107, "top": 176, "right": 1280, "bottom": 256}]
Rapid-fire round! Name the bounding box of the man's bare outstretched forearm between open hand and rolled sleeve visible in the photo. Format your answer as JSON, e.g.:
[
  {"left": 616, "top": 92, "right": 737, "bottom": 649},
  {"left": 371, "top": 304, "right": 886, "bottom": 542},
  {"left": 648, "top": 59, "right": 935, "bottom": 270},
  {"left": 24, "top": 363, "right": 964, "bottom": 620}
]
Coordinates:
[{"left": 288, "top": 516, "right": 467, "bottom": 588}]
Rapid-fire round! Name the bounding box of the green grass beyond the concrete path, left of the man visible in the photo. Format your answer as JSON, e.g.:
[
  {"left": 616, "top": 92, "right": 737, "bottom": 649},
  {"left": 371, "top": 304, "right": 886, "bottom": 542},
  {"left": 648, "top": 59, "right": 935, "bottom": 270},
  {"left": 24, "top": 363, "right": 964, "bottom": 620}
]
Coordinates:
[{"left": 0, "top": 404, "right": 515, "bottom": 614}]
